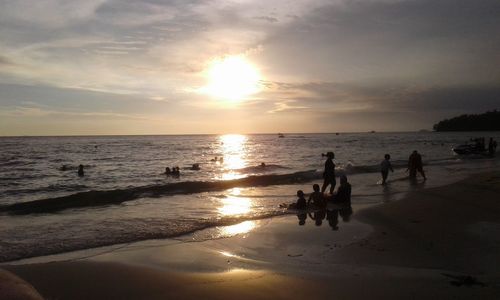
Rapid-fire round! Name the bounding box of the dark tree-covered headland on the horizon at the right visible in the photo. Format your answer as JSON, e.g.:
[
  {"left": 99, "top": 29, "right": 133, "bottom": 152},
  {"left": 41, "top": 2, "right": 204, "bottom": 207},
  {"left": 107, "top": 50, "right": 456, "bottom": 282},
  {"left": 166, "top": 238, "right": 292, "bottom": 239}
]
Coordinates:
[{"left": 433, "top": 109, "right": 500, "bottom": 131}]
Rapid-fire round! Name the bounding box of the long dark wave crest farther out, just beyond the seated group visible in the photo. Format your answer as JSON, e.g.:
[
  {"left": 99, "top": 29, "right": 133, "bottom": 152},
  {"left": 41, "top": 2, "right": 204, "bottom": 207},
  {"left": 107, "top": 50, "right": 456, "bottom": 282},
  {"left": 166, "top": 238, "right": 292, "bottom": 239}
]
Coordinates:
[{"left": 0, "top": 170, "right": 321, "bottom": 214}]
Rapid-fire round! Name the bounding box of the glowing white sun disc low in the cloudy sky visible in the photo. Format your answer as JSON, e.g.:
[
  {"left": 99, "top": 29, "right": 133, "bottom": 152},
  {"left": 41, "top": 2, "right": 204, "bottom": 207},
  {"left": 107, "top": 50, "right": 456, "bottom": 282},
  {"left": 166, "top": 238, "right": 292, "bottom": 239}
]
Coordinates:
[{"left": 203, "top": 55, "right": 260, "bottom": 101}]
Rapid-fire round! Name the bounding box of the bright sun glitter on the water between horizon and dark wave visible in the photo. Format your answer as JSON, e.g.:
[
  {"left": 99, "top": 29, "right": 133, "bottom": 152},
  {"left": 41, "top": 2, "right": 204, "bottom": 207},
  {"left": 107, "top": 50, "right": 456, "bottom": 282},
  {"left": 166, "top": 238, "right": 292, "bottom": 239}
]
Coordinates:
[{"left": 220, "top": 134, "right": 247, "bottom": 180}]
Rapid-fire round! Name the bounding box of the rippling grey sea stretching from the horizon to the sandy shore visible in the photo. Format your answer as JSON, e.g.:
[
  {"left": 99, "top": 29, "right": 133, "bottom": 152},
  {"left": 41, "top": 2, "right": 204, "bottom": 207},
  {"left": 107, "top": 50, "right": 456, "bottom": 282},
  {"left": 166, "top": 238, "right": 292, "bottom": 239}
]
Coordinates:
[{"left": 0, "top": 132, "right": 500, "bottom": 262}]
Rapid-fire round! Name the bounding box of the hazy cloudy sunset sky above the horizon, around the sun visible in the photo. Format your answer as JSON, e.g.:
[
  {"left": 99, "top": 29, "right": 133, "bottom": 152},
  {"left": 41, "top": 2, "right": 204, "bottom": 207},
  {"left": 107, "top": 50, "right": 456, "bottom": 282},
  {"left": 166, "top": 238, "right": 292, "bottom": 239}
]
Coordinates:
[{"left": 0, "top": 0, "right": 500, "bottom": 136}]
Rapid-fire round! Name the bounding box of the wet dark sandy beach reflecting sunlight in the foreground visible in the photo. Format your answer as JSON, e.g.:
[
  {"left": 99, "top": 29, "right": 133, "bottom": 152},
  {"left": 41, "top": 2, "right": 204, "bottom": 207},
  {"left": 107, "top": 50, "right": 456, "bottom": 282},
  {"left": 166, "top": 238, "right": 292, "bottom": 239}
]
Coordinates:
[{"left": 0, "top": 173, "right": 500, "bottom": 299}]
